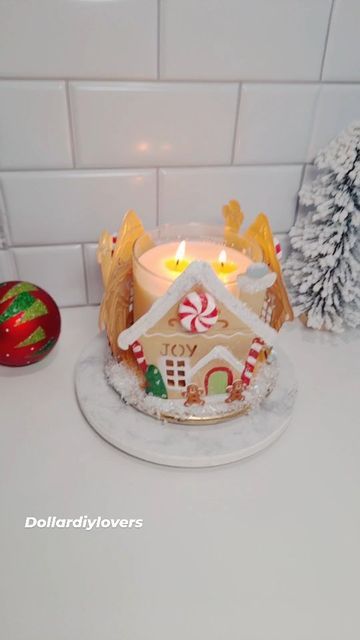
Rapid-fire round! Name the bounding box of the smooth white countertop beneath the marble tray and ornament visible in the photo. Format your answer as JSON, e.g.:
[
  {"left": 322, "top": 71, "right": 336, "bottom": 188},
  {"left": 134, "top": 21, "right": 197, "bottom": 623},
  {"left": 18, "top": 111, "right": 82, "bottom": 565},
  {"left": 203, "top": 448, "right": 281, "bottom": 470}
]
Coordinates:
[{"left": 0, "top": 307, "right": 360, "bottom": 640}]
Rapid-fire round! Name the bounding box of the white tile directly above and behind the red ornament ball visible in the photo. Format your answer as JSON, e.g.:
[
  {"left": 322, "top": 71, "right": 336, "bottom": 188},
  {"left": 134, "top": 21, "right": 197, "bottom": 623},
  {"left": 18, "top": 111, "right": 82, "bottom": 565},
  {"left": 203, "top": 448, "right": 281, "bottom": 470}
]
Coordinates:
[{"left": 13, "top": 245, "right": 86, "bottom": 307}]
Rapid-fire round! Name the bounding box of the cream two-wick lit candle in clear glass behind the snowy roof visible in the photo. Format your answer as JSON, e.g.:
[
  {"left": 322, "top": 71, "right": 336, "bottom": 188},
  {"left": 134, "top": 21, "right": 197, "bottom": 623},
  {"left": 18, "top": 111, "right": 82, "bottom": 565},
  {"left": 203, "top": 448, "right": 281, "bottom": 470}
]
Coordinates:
[{"left": 133, "top": 240, "right": 252, "bottom": 319}]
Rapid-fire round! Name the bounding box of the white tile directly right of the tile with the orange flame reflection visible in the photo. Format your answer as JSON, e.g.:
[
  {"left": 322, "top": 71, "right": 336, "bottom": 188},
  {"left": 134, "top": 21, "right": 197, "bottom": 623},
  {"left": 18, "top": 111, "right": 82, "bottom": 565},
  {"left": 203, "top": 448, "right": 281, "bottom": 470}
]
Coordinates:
[{"left": 235, "top": 84, "right": 318, "bottom": 164}]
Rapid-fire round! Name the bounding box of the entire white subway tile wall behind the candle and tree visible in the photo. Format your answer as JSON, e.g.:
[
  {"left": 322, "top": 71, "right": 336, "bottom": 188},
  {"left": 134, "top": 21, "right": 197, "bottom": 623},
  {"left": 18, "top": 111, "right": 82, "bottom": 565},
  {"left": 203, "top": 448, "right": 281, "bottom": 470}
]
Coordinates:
[{"left": 0, "top": 0, "right": 360, "bottom": 305}]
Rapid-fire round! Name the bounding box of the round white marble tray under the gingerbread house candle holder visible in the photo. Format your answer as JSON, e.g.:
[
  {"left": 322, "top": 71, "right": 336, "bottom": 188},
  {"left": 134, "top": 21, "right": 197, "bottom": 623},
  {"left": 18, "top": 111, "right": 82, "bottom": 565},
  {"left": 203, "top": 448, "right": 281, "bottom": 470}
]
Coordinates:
[{"left": 75, "top": 334, "right": 297, "bottom": 467}]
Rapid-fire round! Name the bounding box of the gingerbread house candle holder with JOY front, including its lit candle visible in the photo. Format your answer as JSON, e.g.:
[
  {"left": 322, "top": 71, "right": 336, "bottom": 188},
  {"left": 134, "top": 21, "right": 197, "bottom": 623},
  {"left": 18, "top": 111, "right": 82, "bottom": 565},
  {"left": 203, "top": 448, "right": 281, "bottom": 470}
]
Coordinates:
[{"left": 98, "top": 201, "right": 293, "bottom": 424}]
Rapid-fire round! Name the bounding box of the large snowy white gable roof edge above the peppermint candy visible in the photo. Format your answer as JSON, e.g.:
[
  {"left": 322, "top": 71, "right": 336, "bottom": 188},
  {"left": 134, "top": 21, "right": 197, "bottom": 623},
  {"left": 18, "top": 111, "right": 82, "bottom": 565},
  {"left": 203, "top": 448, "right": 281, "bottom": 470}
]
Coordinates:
[{"left": 118, "top": 262, "right": 277, "bottom": 349}]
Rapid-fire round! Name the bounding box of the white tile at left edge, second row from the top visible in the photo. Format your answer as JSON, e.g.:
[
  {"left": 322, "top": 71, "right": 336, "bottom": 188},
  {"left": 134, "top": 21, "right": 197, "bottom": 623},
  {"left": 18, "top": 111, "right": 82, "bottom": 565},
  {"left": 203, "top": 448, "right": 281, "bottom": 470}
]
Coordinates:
[{"left": 0, "top": 80, "right": 72, "bottom": 169}]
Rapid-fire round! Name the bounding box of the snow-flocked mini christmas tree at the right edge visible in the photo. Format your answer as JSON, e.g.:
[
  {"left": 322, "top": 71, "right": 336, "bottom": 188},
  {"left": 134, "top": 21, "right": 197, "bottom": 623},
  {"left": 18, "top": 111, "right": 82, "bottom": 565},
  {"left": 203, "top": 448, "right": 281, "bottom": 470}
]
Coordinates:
[{"left": 285, "top": 122, "right": 360, "bottom": 331}]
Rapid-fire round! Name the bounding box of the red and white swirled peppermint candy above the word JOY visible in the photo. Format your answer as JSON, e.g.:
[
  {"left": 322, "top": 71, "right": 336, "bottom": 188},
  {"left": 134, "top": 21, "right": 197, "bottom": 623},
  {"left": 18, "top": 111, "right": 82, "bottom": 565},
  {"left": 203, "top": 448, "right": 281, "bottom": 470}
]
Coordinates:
[{"left": 178, "top": 291, "right": 219, "bottom": 333}]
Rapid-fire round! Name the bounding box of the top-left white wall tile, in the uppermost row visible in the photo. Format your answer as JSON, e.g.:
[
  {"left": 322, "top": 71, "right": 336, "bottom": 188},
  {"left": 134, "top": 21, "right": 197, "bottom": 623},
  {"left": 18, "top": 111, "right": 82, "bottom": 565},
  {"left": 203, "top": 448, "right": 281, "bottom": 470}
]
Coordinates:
[{"left": 0, "top": 0, "right": 157, "bottom": 79}]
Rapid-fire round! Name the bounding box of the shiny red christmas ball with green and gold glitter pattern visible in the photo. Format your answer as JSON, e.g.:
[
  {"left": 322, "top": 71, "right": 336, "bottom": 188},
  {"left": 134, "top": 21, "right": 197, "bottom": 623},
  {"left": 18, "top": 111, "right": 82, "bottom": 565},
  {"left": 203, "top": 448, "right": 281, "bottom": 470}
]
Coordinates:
[{"left": 0, "top": 280, "right": 61, "bottom": 367}]
